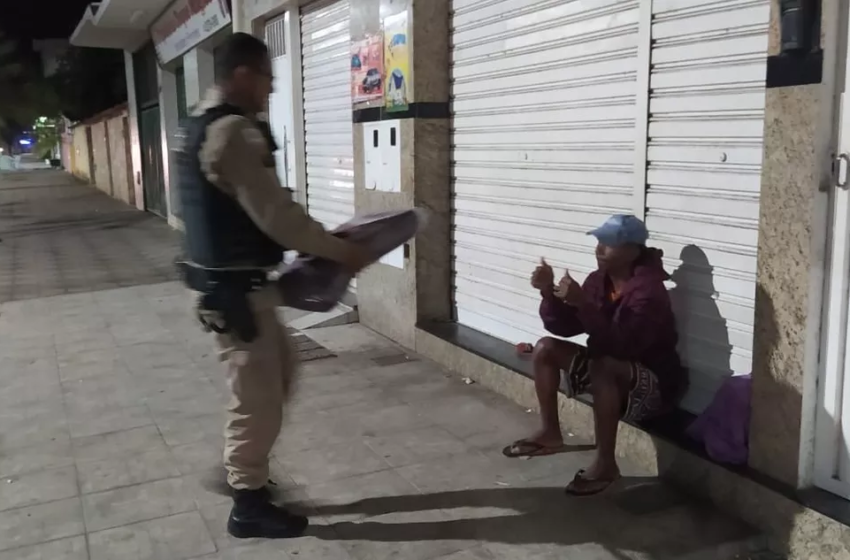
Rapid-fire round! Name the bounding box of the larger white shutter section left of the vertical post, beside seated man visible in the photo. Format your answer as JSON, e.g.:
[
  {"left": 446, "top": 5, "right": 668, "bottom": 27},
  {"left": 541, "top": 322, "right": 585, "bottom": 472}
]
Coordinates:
[{"left": 452, "top": 0, "right": 645, "bottom": 343}]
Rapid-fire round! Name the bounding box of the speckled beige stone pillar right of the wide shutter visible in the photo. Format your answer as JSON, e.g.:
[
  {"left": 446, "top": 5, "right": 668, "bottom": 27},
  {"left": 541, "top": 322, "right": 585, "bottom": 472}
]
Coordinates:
[{"left": 750, "top": 0, "right": 844, "bottom": 488}]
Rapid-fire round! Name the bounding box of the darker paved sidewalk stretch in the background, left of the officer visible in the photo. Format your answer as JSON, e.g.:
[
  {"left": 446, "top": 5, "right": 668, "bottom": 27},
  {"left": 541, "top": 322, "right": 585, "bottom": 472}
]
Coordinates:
[{"left": 0, "top": 170, "right": 179, "bottom": 302}]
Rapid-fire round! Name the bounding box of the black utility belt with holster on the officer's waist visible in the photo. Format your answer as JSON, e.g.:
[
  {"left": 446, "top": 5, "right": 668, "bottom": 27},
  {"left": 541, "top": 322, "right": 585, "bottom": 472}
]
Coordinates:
[{"left": 175, "top": 261, "right": 269, "bottom": 342}]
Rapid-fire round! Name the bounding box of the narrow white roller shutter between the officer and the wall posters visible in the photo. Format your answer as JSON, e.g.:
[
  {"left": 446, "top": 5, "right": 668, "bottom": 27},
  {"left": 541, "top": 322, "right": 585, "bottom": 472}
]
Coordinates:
[{"left": 301, "top": 0, "right": 354, "bottom": 228}]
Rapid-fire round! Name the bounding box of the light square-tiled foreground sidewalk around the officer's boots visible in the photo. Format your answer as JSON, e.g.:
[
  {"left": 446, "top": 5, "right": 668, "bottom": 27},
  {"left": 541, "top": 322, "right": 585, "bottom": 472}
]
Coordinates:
[{"left": 0, "top": 176, "right": 760, "bottom": 560}]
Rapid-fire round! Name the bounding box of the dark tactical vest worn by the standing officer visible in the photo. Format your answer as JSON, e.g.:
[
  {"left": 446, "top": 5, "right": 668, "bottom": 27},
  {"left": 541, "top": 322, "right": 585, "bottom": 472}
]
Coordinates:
[{"left": 177, "top": 105, "right": 286, "bottom": 268}]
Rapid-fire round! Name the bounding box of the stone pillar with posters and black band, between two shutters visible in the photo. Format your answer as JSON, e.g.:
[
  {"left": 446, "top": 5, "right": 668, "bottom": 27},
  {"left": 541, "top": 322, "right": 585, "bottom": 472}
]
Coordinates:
[{"left": 351, "top": 0, "right": 451, "bottom": 348}]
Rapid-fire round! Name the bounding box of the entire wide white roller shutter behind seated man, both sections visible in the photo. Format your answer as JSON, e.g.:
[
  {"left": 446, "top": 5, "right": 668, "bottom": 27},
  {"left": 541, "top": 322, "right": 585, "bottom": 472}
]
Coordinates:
[{"left": 452, "top": 0, "right": 770, "bottom": 412}]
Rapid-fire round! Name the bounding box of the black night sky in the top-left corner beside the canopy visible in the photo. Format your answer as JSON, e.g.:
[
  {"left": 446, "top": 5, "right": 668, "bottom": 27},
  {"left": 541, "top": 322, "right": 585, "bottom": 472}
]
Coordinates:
[{"left": 0, "top": 0, "right": 91, "bottom": 42}]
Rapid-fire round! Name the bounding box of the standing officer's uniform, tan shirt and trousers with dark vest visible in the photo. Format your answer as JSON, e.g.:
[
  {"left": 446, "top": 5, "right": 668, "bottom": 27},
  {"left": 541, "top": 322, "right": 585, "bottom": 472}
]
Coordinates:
[{"left": 179, "top": 88, "right": 348, "bottom": 490}]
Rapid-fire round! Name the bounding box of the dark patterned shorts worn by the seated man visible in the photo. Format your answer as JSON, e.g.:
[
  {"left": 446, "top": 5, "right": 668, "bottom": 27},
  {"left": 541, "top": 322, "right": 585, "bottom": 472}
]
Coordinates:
[{"left": 564, "top": 348, "right": 663, "bottom": 422}]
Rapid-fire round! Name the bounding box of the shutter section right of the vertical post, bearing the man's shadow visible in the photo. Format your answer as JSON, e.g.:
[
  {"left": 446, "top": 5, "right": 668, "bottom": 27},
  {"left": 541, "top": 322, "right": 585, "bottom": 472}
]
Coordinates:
[{"left": 646, "top": 0, "right": 770, "bottom": 412}]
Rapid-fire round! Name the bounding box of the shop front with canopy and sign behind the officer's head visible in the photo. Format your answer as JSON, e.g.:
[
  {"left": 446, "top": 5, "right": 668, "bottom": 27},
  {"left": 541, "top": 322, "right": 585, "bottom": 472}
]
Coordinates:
[{"left": 71, "top": 0, "right": 232, "bottom": 227}]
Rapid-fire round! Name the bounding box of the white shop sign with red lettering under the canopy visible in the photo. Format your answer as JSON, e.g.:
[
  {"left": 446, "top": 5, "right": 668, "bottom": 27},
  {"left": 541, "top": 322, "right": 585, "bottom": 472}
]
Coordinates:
[{"left": 151, "top": 0, "right": 230, "bottom": 64}]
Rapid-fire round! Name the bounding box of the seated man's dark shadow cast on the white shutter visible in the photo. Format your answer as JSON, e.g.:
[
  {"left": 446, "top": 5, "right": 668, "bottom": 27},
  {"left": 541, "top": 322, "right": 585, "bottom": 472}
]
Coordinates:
[{"left": 669, "top": 245, "right": 732, "bottom": 409}]
